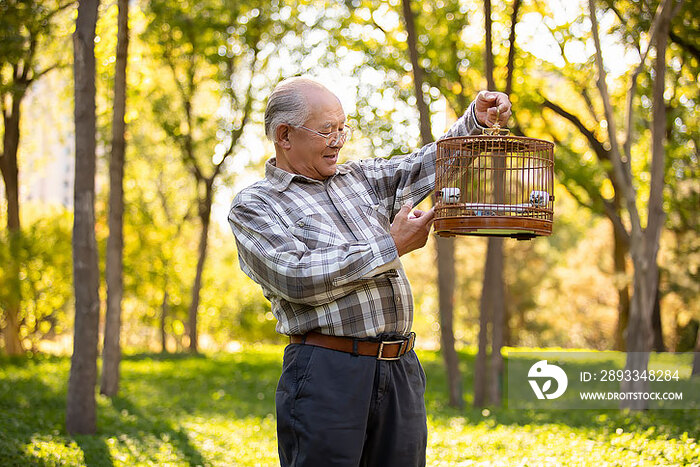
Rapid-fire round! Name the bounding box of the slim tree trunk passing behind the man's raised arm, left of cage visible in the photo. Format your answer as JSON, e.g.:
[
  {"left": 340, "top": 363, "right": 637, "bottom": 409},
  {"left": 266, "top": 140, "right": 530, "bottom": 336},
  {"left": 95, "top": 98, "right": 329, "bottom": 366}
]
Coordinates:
[{"left": 402, "top": 0, "right": 464, "bottom": 407}]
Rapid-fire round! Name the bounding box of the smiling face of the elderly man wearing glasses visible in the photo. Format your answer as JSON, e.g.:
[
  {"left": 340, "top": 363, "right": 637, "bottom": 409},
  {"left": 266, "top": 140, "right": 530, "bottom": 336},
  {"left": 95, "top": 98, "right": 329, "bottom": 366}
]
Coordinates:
[{"left": 278, "top": 87, "right": 345, "bottom": 180}]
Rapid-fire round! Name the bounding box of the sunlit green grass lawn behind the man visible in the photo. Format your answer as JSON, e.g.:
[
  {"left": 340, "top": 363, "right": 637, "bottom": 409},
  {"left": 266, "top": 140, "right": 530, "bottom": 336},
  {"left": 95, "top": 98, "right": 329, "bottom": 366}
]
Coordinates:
[{"left": 0, "top": 346, "right": 700, "bottom": 467}]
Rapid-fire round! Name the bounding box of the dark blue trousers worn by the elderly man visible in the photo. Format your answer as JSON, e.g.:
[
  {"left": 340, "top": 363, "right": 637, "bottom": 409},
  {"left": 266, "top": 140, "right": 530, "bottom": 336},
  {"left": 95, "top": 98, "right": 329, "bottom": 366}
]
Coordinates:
[{"left": 275, "top": 344, "right": 428, "bottom": 467}]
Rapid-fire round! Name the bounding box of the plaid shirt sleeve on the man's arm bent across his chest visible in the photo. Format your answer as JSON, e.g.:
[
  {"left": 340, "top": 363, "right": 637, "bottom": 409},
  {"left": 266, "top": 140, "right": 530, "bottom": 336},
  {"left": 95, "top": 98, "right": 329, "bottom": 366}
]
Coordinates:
[{"left": 228, "top": 201, "right": 398, "bottom": 306}]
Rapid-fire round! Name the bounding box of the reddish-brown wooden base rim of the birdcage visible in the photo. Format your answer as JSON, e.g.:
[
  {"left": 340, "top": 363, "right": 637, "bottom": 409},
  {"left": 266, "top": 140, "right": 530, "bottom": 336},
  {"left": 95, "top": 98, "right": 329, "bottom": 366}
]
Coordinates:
[{"left": 433, "top": 216, "right": 552, "bottom": 240}]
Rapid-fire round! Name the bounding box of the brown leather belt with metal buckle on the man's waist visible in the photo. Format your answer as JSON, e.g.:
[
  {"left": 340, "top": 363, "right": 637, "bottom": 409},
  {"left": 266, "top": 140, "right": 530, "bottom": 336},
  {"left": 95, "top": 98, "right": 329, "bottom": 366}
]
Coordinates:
[{"left": 289, "top": 332, "right": 416, "bottom": 360}]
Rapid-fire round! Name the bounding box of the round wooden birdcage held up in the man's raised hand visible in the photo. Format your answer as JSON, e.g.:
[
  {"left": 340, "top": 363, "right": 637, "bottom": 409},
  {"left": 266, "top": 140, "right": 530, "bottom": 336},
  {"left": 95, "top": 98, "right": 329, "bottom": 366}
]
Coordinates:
[{"left": 434, "top": 128, "right": 554, "bottom": 240}]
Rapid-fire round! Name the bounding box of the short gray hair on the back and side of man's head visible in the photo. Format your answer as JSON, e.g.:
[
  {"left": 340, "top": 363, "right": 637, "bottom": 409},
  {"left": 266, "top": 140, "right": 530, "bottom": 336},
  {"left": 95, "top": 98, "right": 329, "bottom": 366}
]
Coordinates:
[{"left": 265, "top": 77, "right": 325, "bottom": 142}]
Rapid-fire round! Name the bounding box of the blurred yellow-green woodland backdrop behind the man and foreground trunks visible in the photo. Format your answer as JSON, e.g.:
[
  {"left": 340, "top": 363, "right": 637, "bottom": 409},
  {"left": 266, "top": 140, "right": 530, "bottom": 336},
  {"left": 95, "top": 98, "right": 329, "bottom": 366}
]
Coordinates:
[{"left": 0, "top": 0, "right": 700, "bottom": 402}]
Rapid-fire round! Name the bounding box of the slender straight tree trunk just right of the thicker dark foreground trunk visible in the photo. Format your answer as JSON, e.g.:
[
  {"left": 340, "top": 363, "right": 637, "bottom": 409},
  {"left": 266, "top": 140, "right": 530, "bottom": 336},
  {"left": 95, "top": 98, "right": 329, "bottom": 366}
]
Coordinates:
[{"left": 100, "top": 0, "right": 129, "bottom": 397}]
